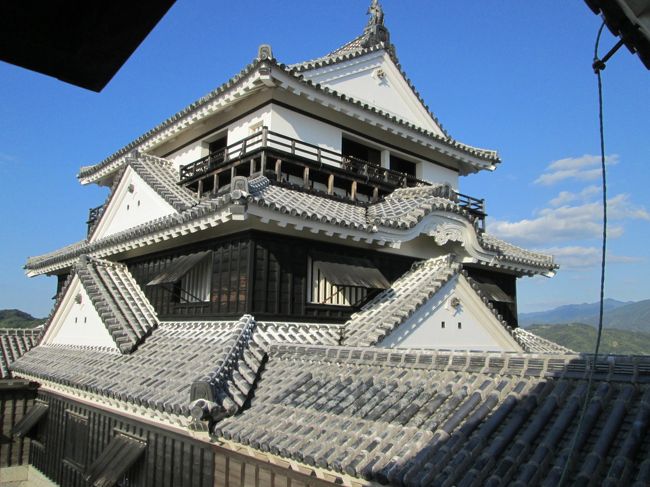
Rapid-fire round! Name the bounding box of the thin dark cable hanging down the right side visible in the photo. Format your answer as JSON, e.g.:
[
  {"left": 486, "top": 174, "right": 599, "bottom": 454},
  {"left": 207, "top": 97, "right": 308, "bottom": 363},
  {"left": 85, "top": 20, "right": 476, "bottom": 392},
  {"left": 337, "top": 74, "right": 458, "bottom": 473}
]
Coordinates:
[{"left": 558, "top": 21, "right": 604, "bottom": 487}]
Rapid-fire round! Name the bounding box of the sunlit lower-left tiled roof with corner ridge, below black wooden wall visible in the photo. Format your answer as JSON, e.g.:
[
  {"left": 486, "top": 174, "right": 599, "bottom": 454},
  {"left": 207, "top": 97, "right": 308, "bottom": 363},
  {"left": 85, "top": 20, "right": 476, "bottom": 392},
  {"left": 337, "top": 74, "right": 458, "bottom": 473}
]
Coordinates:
[{"left": 12, "top": 315, "right": 340, "bottom": 416}]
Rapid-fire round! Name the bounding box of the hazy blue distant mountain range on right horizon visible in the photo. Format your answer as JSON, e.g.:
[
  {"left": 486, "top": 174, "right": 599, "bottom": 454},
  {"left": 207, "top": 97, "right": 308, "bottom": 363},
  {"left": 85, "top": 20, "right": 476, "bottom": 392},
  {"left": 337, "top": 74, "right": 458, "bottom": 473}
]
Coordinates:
[{"left": 519, "top": 299, "right": 650, "bottom": 333}]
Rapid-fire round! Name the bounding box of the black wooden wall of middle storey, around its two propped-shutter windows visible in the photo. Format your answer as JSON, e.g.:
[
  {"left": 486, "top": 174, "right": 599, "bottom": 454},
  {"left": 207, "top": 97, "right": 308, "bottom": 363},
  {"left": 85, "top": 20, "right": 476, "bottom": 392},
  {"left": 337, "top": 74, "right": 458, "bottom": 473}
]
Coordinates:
[{"left": 127, "top": 231, "right": 416, "bottom": 321}]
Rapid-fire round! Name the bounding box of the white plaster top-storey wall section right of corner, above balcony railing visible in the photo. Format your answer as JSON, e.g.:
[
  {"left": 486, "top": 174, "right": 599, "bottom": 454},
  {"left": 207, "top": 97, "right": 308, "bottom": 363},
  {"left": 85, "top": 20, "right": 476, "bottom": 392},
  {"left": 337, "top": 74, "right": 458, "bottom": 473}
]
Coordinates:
[{"left": 270, "top": 105, "right": 343, "bottom": 156}]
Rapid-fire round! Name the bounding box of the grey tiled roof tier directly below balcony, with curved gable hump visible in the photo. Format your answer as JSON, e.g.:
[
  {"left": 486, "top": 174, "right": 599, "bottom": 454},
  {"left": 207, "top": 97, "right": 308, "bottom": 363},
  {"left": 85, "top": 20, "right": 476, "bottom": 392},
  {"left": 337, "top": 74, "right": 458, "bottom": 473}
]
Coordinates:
[{"left": 25, "top": 176, "right": 557, "bottom": 278}]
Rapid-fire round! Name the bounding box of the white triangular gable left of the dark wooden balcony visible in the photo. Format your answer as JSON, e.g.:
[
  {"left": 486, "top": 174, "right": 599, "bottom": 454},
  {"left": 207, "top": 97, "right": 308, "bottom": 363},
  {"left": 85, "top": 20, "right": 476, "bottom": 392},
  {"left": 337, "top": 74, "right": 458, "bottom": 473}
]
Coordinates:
[{"left": 90, "top": 166, "right": 176, "bottom": 242}]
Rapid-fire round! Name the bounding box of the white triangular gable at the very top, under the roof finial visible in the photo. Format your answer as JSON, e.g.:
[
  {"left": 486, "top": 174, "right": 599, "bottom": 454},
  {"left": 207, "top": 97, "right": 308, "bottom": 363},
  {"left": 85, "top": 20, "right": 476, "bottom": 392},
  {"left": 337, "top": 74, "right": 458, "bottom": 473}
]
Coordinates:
[{"left": 301, "top": 50, "right": 445, "bottom": 137}]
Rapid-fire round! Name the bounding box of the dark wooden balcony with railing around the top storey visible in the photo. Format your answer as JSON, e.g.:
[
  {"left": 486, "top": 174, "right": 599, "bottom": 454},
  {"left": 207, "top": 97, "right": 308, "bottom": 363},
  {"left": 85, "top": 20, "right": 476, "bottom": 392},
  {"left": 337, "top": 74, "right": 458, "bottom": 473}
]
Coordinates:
[{"left": 180, "top": 127, "right": 486, "bottom": 229}]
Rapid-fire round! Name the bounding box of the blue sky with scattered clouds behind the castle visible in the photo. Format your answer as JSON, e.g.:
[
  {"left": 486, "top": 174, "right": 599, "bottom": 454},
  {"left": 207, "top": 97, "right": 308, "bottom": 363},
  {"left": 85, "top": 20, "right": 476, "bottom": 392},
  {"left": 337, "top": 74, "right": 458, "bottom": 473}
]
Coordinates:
[{"left": 0, "top": 0, "right": 650, "bottom": 316}]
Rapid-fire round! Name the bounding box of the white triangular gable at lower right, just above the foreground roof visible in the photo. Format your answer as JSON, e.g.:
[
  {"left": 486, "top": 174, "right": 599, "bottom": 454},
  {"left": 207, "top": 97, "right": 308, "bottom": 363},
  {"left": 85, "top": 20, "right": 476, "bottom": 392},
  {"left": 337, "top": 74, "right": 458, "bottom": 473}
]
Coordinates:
[{"left": 378, "top": 275, "right": 523, "bottom": 352}]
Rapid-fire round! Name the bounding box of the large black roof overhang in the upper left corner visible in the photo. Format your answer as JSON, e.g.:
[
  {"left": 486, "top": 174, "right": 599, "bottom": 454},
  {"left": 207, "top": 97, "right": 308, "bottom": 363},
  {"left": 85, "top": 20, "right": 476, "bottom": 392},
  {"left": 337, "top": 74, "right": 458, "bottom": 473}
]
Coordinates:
[{"left": 0, "top": 0, "right": 175, "bottom": 92}]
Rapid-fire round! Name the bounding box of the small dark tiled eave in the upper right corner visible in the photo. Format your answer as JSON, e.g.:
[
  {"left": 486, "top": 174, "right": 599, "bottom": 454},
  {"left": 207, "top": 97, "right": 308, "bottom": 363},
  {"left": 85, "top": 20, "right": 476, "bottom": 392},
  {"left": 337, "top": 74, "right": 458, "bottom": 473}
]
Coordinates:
[{"left": 585, "top": 0, "right": 650, "bottom": 69}]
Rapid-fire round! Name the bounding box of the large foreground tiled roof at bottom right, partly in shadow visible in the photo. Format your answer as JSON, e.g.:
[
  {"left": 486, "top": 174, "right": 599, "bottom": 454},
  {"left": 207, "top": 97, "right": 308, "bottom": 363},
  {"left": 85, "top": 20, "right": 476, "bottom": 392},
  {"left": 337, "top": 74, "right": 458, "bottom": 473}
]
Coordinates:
[{"left": 214, "top": 346, "right": 650, "bottom": 487}]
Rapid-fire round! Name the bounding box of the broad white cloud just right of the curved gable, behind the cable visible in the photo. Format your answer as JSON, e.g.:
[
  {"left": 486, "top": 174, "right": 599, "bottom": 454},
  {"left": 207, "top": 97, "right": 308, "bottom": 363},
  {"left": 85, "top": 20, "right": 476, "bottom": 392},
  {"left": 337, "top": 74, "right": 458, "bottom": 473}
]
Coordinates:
[{"left": 489, "top": 194, "right": 650, "bottom": 247}]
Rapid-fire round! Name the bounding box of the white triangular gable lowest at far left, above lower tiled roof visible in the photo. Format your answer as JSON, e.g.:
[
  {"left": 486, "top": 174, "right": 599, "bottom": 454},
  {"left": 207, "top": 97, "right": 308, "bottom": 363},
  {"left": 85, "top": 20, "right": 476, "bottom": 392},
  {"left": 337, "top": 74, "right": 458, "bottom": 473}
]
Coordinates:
[{"left": 42, "top": 276, "right": 120, "bottom": 352}]
